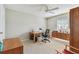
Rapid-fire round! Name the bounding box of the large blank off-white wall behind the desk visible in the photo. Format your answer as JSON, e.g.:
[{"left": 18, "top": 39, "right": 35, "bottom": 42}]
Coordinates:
[{"left": 5, "top": 9, "right": 45, "bottom": 39}]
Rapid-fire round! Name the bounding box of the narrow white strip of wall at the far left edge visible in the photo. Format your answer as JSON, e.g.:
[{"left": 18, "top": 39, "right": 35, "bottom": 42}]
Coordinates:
[{"left": 0, "top": 4, "right": 5, "bottom": 41}]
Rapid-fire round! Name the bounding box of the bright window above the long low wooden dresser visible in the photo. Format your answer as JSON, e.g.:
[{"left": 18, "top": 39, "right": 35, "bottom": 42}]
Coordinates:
[{"left": 57, "top": 13, "right": 70, "bottom": 33}]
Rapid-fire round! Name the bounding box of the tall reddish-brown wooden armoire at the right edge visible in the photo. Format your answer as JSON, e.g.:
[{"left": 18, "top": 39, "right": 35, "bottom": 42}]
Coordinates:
[{"left": 70, "top": 7, "right": 79, "bottom": 53}]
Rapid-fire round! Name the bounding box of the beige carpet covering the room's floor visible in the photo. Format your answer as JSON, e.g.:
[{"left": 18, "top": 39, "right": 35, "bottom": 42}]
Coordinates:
[{"left": 23, "top": 38, "right": 68, "bottom": 54}]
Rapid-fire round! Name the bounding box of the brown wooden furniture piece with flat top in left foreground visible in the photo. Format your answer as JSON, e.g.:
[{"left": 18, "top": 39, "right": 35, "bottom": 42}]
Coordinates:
[{"left": 1, "top": 38, "right": 23, "bottom": 54}]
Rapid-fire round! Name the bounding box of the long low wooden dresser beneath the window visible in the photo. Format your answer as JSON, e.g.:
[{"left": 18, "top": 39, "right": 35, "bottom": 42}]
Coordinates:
[{"left": 52, "top": 31, "right": 70, "bottom": 40}]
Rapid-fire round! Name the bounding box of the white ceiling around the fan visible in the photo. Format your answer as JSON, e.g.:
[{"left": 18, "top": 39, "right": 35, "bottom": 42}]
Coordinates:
[{"left": 5, "top": 4, "right": 79, "bottom": 17}]
